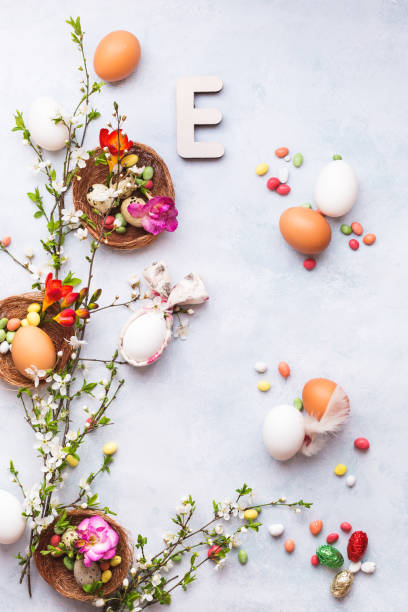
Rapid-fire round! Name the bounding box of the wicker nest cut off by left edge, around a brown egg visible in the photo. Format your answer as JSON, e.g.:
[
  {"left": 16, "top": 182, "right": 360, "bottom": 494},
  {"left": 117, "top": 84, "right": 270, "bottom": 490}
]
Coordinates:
[{"left": 0, "top": 291, "right": 71, "bottom": 387}]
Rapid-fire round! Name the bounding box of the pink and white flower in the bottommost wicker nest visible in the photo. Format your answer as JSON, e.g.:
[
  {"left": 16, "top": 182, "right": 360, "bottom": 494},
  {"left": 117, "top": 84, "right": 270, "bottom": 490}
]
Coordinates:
[{"left": 75, "top": 516, "right": 119, "bottom": 567}]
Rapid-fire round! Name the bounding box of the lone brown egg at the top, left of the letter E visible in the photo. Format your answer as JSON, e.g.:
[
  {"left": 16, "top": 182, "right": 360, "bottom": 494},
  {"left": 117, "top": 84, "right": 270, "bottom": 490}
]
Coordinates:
[{"left": 94, "top": 30, "right": 140, "bottom": 82}]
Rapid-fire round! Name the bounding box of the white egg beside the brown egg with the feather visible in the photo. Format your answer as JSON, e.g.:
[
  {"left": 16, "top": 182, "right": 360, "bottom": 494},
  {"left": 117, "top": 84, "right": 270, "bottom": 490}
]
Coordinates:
[{"left": 262, "top": 404, "right": 305, "bottom": 461}]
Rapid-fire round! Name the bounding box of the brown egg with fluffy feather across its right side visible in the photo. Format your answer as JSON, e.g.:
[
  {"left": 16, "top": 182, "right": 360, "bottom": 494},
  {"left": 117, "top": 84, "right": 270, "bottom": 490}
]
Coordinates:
[{"left": 302, "top": 378, "right": 350, "bottom": 421}]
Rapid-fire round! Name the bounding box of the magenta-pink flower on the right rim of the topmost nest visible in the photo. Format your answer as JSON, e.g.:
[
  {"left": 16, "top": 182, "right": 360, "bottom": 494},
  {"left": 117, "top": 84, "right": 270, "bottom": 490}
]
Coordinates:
[{"left": 128, "top": 196, "right": 178, "bottom": 235}]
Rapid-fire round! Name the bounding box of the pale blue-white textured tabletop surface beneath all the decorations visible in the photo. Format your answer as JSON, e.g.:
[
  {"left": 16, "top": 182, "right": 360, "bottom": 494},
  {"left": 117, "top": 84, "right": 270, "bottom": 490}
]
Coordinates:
[{"left": 0, "top": 0, "right": 408, "bottom": 612}]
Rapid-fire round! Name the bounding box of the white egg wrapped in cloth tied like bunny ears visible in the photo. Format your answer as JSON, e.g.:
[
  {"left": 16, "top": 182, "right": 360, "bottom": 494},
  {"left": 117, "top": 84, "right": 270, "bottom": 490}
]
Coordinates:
[{"left": 119, "top": 310, "right": 172, "bottom": 366}]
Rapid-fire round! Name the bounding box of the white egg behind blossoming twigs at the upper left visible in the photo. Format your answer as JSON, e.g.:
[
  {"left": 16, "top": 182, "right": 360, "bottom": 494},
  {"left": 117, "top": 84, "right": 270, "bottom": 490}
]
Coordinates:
[{"left": 27, "top": 98, "right": 68, "bottom": 151}]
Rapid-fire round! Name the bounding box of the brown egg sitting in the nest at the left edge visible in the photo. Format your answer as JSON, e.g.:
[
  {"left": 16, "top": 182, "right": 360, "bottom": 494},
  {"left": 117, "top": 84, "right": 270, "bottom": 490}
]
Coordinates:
[{"left": 11, "top": 325, "right": 56, "bottom": 378}]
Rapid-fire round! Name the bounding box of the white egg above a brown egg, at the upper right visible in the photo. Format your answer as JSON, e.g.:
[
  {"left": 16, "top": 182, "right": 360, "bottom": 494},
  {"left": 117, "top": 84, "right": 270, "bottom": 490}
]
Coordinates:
[{"left": 314, "top": 159, "right": 358, "bottom": 217}]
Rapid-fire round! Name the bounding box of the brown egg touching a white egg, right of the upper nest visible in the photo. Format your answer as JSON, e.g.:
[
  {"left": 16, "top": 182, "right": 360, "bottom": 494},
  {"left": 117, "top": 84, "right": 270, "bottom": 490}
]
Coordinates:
[{"left": 279, "top": 206, "right": 331, "bottom": 255}]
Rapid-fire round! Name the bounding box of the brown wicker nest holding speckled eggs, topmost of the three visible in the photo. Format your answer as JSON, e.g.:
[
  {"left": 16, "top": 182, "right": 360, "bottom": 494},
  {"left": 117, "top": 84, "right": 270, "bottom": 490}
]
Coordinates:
[{"left": 73, "top": 142, "right": 174, "bottom": 251}]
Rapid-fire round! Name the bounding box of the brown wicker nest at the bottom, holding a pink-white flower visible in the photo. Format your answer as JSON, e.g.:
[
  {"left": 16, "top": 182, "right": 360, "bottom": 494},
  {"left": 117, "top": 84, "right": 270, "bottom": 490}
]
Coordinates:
[{"left": 34, "top": 509, "right": 133, "bottom": 601}]
